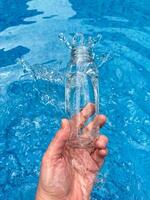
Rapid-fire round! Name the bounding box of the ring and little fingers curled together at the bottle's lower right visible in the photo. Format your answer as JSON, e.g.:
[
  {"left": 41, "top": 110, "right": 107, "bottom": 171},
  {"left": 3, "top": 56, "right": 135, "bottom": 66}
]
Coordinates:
[{"left": 91, "top": 135, "right": 108, "bottom": 167}]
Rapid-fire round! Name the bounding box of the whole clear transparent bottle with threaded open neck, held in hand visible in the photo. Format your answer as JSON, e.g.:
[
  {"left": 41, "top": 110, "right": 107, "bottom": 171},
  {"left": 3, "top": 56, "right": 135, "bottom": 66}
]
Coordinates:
[{"left": 65, "top": 33, "right": 99, "bottom": 148}]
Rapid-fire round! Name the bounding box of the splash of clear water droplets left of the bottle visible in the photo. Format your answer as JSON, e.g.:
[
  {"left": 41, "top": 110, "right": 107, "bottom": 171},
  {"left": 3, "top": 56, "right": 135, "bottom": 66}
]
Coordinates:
[{"left": 17, "top": 58, "right": 64, "bottom": 105}]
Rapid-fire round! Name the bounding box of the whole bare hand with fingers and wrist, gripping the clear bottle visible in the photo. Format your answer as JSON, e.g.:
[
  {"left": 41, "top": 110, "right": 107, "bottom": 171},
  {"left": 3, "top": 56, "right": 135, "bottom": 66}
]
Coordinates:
[{"left": 36, "top": 103, "right": 108, "bottom": 200}]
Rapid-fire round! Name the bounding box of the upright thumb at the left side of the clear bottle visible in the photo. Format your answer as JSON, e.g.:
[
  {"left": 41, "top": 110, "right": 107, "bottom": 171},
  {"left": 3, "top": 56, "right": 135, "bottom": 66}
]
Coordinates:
[{"left": 46, "top": 119, "right": 70, "bottom": 158}]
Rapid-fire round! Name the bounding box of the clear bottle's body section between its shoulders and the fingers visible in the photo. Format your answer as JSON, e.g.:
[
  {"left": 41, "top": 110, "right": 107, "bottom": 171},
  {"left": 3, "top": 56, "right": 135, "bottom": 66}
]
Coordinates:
[{"left": 65, "top": 64, "right": 99, "bottom": 117}]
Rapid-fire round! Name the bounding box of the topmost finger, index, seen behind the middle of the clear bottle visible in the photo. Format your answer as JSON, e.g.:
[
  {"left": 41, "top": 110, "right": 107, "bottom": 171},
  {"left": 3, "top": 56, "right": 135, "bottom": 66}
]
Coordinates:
[{"left": 71, "top": 103, "right": 95, "bottom": 128}]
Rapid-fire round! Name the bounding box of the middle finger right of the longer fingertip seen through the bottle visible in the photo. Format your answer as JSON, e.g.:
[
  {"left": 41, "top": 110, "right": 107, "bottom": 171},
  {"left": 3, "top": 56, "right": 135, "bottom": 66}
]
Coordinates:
[{"left": 83, "top": 115, "right": 106, "bottom": 137}]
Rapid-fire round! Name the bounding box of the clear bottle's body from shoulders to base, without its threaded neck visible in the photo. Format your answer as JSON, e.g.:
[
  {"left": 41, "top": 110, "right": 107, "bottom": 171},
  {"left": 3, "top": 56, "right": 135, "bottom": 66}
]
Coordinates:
[{"left": 65, "top": 55, "right": 99, "bottom": 148}]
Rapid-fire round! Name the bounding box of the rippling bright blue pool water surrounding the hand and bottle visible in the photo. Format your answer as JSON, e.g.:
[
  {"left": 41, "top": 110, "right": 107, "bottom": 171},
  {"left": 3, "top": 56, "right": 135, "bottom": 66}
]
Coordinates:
[{"left": 0, "top": 0, "right": 150, "bottom": 200}]
